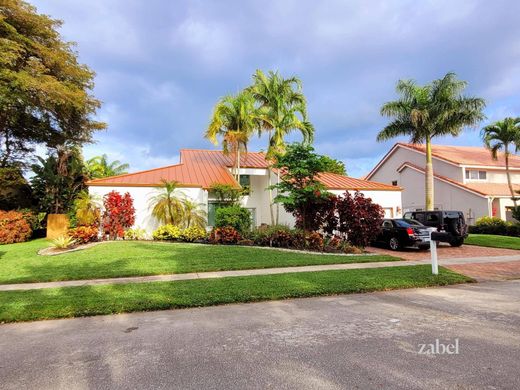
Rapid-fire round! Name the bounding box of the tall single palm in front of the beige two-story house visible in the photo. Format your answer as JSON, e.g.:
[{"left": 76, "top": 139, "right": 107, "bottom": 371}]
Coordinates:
[{"left": 377, "top": 73, "right": 485, "bottom": 210}]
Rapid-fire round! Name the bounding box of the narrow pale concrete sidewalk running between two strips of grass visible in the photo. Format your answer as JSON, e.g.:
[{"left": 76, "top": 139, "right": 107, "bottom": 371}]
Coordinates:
[{"left": 0, "top": 254, "right": 520, "bottom": 291}]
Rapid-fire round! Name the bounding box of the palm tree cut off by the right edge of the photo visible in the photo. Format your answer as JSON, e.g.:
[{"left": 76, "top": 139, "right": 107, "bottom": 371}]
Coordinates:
[{"left": 481, "top": 118, "right": 520, "bottom": 209}]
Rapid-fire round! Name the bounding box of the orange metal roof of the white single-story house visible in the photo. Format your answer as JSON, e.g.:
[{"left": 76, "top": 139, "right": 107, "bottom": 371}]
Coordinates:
[{"left": 87, "top": 149, "right": 402, "bottom": 191}]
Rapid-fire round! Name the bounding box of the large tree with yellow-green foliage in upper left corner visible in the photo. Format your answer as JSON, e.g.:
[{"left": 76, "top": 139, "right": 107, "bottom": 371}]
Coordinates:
[{"left": 0, "top": 0, "right": 105, "bottom": 167}]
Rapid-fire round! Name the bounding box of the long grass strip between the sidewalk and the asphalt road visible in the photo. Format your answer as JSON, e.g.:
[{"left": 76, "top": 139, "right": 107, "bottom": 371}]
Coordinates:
[{"left": 0, "top": 265, "right": 472, "bottom": 322}]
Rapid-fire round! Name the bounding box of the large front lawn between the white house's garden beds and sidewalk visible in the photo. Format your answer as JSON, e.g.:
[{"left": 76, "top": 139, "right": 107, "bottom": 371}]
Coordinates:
[{"left": 0, "top": 240, "right": 401, "bottom": 284}]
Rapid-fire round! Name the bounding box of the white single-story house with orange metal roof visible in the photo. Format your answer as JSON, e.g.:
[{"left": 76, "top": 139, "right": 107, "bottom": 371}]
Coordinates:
[{"left": 87, "top": 149, "right": 401, "bottom": 232}]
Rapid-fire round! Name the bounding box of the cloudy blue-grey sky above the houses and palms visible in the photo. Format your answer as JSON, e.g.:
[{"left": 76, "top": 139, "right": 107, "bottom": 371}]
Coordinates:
[{"left": 30, "top": 0, "right": 520, "bottom": 177}]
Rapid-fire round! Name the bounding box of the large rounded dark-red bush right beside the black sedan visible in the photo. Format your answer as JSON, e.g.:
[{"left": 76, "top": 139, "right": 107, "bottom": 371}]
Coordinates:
[{"left": 336, "top": 192, "right": 384, "bottom": 247}]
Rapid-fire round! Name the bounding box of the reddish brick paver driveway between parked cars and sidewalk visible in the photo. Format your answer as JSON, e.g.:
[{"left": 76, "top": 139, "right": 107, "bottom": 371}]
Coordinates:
[{"left": 367, "top": 244, "right": 520, "bottom": 260}]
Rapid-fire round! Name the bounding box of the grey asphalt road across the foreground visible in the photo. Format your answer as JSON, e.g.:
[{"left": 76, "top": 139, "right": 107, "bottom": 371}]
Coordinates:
[{"left": 0, "top": 280, "right": 520, "bottom": 389}]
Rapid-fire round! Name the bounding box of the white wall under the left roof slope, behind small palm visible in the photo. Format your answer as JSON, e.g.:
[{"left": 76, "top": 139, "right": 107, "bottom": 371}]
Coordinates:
[{"left": 89, "top": 186, "right": 208, "bottom": 234}]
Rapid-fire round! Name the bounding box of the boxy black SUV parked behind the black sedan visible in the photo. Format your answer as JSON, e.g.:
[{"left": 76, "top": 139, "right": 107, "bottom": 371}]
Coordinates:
[{"left": 404, "top": 210, "right": 468, "bottom": 246}]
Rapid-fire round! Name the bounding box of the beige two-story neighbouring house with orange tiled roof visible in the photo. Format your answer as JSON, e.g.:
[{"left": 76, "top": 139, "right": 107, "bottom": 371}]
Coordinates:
[{"left": 366, "top": 143, "right": 520, "bottom": 224}]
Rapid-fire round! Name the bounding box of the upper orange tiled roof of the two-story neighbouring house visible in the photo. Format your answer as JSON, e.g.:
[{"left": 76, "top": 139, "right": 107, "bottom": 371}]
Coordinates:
[{"left": 398, "top": 142, "right": 520, "bottom": 168}]
